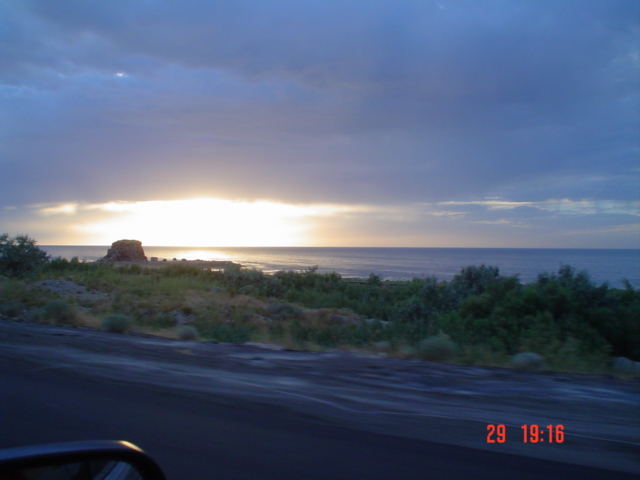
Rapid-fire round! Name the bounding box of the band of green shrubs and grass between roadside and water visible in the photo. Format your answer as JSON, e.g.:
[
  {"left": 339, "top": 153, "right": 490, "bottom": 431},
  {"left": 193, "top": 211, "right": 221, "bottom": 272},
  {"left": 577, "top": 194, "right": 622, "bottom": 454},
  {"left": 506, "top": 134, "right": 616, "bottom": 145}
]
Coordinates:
[{"left": 0, "top": 232, "right": 640, "bottom": 373}]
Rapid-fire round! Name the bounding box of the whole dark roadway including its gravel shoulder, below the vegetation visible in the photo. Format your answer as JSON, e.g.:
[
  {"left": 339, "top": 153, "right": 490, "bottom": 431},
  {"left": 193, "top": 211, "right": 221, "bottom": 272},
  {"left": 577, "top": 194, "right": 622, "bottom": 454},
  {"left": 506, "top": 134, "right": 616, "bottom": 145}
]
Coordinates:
[{"left": 0, "top": 320, "right": 640, "bottom": 479}]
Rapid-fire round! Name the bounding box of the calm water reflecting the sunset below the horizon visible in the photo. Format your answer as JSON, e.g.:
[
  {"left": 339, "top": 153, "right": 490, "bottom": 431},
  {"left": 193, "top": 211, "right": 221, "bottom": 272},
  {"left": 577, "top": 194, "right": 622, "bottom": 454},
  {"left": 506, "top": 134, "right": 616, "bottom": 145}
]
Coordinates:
[{"left": 41, "top": 245, "right": 640, "bottom": 288}]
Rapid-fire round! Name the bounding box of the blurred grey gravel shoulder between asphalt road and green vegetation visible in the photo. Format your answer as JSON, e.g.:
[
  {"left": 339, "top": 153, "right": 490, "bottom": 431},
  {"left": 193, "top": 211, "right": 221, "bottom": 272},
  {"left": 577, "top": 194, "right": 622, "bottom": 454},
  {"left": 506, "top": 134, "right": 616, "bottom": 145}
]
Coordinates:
[{"left": 0, "top": 318, "right": 640, "bottom": 474}]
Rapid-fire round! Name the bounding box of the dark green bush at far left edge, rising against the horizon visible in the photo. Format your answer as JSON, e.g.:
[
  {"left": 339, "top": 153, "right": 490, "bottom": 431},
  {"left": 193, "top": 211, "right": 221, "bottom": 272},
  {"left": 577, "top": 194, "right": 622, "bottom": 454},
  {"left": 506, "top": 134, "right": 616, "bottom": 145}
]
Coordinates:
[{"left": 0, "top": 233, "right": 49, "bottom": 277}]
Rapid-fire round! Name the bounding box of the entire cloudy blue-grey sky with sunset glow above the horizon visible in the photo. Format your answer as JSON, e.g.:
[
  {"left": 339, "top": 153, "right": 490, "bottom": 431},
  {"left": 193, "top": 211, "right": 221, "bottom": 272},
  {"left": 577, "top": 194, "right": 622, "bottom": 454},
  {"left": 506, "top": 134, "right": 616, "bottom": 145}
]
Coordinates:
[{"left": 0, "top": 0, "right": 640, "bottom": 248}]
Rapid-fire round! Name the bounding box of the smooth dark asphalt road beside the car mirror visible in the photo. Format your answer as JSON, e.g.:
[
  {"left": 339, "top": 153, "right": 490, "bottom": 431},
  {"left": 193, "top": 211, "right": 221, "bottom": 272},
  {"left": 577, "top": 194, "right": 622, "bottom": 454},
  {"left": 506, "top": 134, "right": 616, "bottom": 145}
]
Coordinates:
[{"left": 0, "top": 364, "right": 639, "bottom": 480}]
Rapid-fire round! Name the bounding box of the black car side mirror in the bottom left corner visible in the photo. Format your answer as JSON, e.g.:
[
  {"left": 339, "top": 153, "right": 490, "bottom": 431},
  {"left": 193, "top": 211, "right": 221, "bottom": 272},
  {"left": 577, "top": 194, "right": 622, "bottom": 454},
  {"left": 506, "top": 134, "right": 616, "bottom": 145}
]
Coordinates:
[{"left": 0, "top": 440, "right": 166, "bottom": 480}]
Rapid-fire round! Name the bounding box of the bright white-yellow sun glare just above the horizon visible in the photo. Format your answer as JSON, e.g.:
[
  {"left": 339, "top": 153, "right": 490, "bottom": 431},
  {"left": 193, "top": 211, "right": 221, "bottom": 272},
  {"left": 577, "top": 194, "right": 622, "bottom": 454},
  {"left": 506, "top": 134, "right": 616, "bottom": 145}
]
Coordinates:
[{"left": 75, "top": 198, "right": 340, "bottom": 247}]
